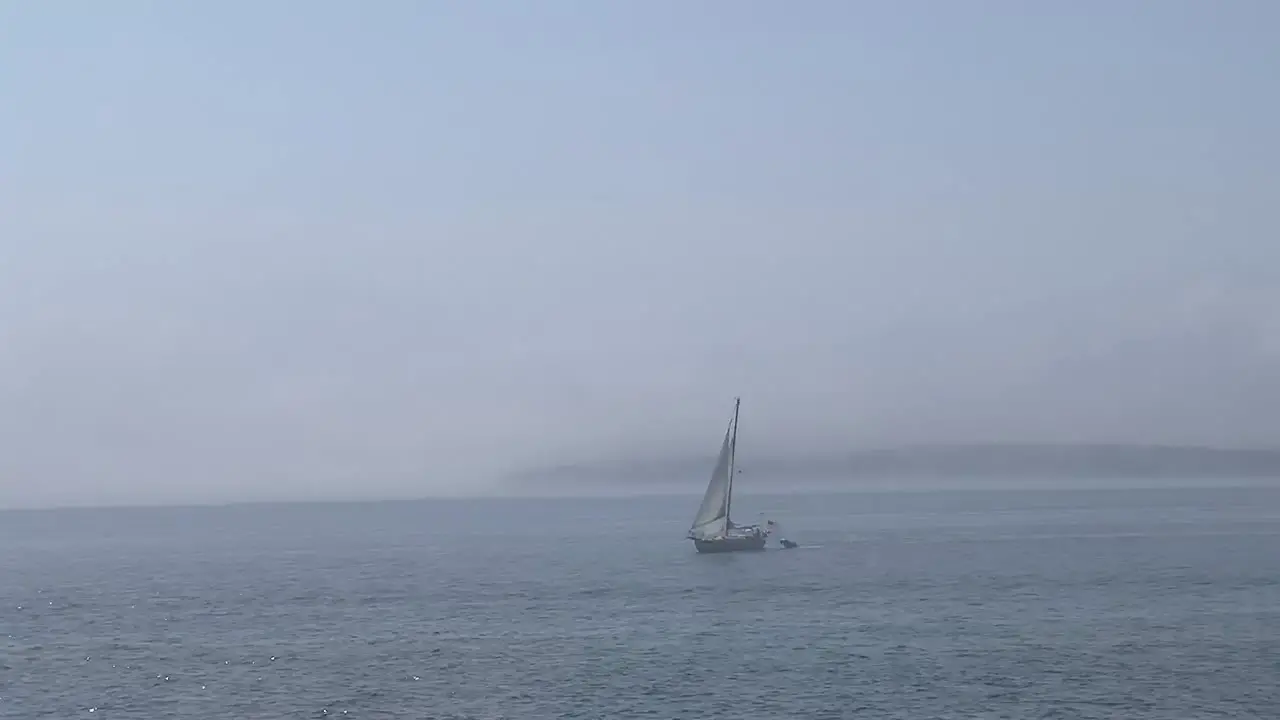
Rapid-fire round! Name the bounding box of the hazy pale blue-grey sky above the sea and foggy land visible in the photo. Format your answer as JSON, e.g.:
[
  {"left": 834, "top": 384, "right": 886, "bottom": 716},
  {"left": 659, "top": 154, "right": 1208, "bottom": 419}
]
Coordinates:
[{"left": 0, "top": 0, "right": 1280, "bottom": 506}]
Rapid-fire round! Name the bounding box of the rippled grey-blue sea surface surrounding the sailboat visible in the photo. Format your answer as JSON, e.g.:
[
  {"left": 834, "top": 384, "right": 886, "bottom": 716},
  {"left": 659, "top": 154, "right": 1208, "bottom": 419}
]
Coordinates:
[{"left": 0, "top": 487, "right": 1280, "bottom": 720}]
